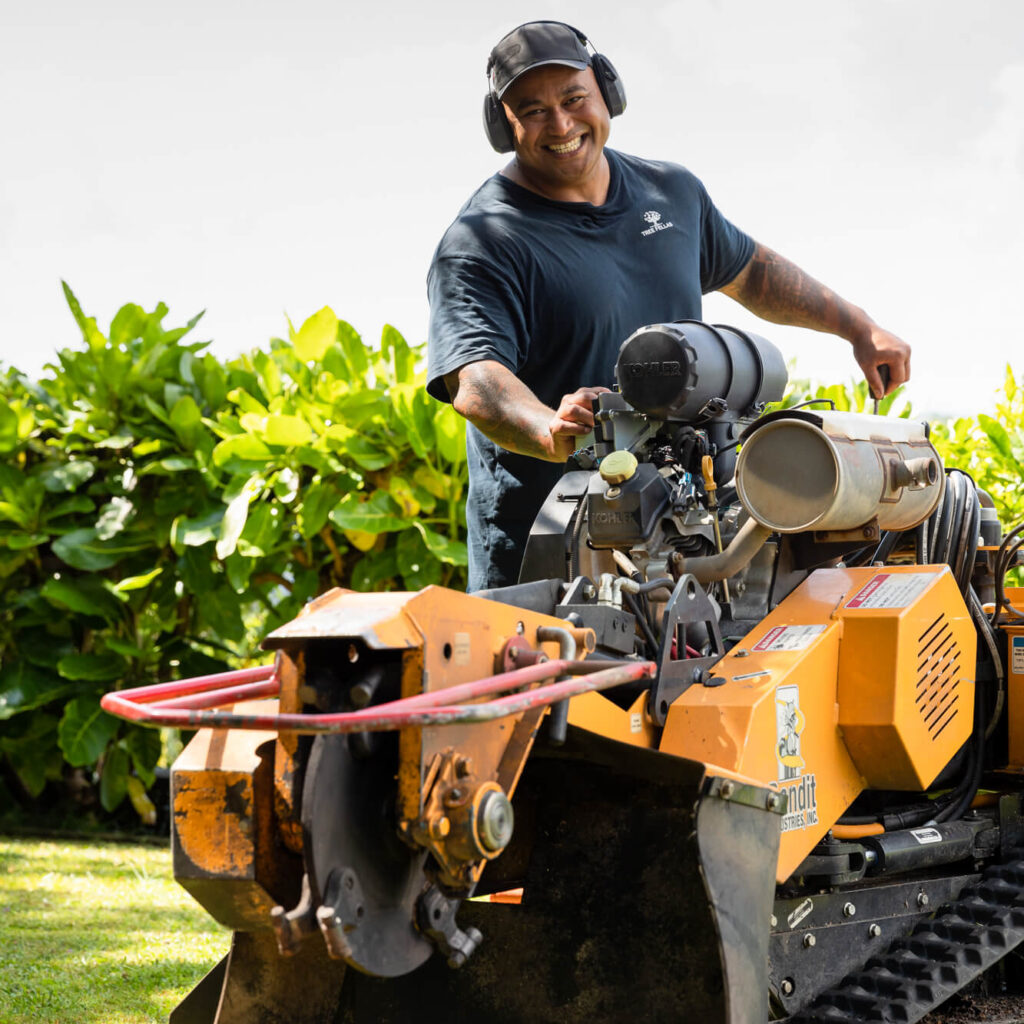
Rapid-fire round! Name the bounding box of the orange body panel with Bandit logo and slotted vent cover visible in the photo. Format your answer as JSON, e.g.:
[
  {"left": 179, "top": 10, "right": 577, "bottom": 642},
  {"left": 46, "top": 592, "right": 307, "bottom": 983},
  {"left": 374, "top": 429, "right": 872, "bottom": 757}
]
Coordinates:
[{"left": 660, "top": 565, "right": 976, "bottom": 882}]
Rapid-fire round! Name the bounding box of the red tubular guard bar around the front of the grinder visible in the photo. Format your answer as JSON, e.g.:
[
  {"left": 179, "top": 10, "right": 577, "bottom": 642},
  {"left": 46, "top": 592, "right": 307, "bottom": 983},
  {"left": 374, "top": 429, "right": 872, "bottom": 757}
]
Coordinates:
[{"left": 100, "top": 658, "right": 656, "bottom": 733}]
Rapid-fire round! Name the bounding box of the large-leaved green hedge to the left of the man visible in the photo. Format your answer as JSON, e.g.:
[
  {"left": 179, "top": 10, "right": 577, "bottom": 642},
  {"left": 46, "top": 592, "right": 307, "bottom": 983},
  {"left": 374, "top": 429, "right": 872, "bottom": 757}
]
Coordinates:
[{"left": 0, "top": 286, "right": 467, "bottom": 823}]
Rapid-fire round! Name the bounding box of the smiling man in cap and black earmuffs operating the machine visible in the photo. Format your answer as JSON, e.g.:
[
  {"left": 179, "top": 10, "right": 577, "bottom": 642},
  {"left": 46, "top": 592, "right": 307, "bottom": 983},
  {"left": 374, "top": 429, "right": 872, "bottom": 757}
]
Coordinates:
[{"left": 427, "top": 22, "right": 910, "bottom": 591}]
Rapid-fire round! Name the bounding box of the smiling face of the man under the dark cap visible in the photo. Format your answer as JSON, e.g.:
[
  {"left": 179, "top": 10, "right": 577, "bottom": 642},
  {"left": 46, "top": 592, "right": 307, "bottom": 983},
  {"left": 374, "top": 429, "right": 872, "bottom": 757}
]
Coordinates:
[{"left": 502, "top": 65, "right": 610, "bottom": 199}]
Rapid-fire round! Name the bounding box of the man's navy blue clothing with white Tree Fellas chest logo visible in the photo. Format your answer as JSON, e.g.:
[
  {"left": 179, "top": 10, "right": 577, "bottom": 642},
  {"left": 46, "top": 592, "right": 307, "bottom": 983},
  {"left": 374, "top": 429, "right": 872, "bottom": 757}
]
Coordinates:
[{"left": 427, "top": 150, "right": 754, "bottom": 591}]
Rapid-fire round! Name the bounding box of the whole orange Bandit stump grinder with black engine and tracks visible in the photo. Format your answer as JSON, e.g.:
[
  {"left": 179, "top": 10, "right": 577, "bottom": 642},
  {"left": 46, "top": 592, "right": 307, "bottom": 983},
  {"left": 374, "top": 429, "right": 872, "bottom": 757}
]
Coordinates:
[{"left": 104, "top": 322, "right": 1024, "bottom": 1024}]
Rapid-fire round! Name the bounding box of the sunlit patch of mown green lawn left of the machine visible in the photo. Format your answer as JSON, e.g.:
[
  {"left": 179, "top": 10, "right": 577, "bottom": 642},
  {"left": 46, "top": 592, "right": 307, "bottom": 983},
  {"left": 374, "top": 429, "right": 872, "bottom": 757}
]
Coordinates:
[{"left": 0, "top": 837, "right": 230, "bottom": 1024}]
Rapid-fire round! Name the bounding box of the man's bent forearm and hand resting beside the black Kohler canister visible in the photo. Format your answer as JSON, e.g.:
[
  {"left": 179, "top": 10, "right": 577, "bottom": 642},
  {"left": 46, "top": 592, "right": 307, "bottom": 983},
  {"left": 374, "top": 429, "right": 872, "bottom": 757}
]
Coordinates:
[{"left": 444, "top": 359, "right": 608, "bottom": 462}]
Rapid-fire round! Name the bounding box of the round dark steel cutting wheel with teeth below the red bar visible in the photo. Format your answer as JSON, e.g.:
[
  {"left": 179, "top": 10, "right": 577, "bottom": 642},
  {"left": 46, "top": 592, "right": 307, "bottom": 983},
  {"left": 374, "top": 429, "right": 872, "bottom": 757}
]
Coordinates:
[{"left": 302, "top": 734, "right": 433, "bottom": 978}]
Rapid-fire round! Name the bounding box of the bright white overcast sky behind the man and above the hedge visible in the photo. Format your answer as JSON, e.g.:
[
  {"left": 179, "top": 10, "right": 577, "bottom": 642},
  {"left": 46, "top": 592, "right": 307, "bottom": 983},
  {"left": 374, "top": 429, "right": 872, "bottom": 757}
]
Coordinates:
[{"left": 0, "top": 0, "right": 1024, "bottom": 414}]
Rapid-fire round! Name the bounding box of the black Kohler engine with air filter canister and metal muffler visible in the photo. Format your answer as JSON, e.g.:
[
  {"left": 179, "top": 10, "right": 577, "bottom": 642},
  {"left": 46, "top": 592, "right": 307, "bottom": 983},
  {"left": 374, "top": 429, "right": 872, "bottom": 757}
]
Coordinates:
[{"left": 512, "top": 321, "right": 944, "bottom": 720}]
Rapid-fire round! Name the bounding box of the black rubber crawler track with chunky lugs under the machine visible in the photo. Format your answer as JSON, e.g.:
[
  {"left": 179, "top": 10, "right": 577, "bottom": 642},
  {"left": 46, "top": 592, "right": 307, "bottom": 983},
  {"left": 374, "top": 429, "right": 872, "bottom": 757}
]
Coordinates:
[{"left": 788, "top": 860, "right": 1024, "bottom": 1024}]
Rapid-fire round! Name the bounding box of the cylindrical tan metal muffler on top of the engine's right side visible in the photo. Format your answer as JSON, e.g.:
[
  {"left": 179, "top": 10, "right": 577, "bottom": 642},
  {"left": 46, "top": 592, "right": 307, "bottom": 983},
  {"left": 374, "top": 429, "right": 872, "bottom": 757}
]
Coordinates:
[{"left": 736, "top": 410, "right": 945, "bottom": 534}]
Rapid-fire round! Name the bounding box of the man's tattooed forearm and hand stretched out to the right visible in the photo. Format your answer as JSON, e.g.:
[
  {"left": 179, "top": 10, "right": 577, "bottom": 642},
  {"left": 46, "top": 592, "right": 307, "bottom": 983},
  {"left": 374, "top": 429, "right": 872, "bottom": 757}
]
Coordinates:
[{"left": 721, "top": 243, "right": 910, "bottom": 397}]
